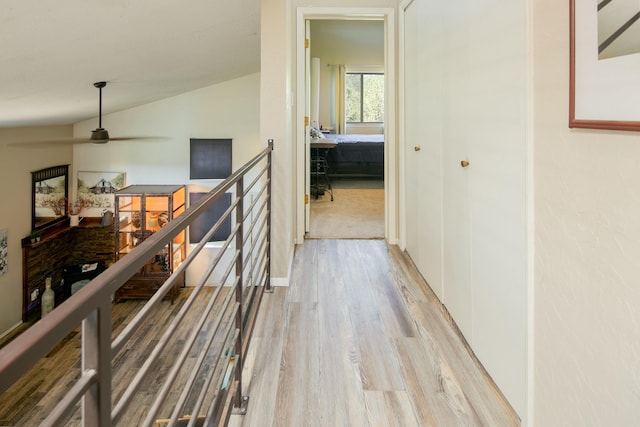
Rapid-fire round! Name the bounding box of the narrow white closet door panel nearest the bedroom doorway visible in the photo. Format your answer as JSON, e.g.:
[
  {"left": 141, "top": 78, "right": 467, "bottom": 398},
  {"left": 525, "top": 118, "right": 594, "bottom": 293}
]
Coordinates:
[{"left": 404, "top": 2, "right": 443, "bottom": 299}]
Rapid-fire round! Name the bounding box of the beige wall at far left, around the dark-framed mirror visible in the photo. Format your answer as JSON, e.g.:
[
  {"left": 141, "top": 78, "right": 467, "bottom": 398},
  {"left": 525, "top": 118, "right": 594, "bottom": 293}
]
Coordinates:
[{"left": 0, "top": 126, "right": 72, "bottom": 337}]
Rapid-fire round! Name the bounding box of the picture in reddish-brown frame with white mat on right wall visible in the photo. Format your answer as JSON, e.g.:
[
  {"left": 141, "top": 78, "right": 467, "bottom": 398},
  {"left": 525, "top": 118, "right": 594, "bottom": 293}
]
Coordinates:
[{"left": 569, "top": 0, "right": 640, "bottom": 131}]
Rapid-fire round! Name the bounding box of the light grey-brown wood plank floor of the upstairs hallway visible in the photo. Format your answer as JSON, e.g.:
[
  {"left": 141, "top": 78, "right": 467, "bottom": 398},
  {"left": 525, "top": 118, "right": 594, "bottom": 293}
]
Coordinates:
[{"left": 230, "top": 240, "right": 520, "bottom": 427}]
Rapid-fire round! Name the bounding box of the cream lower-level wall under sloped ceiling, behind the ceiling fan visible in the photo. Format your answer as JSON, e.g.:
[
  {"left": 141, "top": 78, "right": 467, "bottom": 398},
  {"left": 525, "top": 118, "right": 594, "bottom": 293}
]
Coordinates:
[{"left": 74, "top": 74, "right": 266, "bottom": 184}]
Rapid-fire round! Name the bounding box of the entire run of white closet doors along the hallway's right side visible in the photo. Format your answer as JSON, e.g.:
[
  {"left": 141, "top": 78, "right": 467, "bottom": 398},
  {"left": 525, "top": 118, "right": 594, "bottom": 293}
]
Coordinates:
[{"left": 403, "top": 0, "right": 528, "bottom": 415}]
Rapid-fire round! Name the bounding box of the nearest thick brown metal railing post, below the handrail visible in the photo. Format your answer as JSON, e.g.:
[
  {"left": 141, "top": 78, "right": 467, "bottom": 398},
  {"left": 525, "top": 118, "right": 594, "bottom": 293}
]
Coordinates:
[{"left": 81, "top": 301, "right": 111, "bottom": 427}]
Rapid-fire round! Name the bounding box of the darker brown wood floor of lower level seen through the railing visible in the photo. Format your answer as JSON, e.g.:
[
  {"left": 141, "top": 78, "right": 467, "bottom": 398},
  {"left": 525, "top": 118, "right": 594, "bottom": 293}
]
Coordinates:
[{"left": 0, "top": 287, "right": 227, "bottom": 426}]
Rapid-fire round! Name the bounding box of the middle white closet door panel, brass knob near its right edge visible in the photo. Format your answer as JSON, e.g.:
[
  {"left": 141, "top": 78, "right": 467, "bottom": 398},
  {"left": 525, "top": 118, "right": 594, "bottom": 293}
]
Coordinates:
[{"left": 437, "top": 0, "right": 473, "bottom": 342}]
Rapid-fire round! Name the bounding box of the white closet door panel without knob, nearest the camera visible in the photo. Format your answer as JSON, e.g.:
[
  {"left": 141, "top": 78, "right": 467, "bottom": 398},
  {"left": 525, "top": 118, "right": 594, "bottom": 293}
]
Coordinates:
[{"left": 468, "top": 0, "right": 529, "bottom": 414}]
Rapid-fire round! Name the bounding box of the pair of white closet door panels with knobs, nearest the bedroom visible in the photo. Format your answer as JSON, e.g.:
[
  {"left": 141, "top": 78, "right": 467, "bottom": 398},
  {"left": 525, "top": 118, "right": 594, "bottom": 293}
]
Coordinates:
[{"left": 404, "top": 0, "right": 473, "bottom": 342}]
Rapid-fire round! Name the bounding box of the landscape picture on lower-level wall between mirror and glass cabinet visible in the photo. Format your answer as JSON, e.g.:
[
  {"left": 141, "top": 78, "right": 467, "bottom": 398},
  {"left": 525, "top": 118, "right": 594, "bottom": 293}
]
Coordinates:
[{"left": 76, "top": 171, "right": 127, "bottom": 217}]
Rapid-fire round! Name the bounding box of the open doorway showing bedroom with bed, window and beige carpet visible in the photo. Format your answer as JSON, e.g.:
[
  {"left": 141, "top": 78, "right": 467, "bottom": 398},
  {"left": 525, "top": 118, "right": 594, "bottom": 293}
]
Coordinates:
[{"left": 306, "top": 19, "right": 386, "bottom": 239}]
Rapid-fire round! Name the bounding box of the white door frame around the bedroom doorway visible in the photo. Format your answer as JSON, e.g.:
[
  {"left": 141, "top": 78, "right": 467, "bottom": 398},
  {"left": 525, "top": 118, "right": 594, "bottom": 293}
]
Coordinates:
[{"left": 293, "top": 7, "right": 399, "bottom": 244}]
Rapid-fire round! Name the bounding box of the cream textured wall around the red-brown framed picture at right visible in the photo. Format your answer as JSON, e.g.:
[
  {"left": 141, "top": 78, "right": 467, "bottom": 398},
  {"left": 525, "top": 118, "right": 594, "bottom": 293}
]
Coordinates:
[{"left": 533, "top": 0, "right": 640, "bottom": 426}]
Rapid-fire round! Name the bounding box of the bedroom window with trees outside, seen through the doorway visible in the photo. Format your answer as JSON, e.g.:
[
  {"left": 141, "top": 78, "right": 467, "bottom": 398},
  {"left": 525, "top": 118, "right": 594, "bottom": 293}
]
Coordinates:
[{"left": 345, "top": 73, "right": 384, "bottom": 123}]
